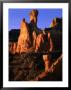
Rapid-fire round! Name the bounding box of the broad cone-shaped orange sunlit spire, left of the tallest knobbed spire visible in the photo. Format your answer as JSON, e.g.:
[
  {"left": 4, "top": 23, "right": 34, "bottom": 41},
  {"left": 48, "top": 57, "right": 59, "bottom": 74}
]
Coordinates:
[{"left": 16, "top": 19, "right": 31, "bottom": 53}]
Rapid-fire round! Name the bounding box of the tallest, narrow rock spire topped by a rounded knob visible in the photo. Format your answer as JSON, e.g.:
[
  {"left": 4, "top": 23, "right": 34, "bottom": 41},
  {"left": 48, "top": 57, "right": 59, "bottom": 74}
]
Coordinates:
[{"left": 29, "top": 9, "right": 39, "bottom": 47}]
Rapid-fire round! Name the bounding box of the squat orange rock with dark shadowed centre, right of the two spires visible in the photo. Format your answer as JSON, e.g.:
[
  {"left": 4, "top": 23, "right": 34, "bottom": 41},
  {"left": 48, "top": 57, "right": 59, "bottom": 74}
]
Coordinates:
[{"left": 35, "top": 31, "right": 53, "bottom": 52}]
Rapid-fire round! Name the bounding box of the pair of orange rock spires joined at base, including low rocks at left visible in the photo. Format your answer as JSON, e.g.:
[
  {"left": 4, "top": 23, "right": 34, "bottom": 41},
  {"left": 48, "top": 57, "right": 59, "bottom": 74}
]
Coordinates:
[{"left": 9, "top": 9, "right": 38, "bottom": 54}]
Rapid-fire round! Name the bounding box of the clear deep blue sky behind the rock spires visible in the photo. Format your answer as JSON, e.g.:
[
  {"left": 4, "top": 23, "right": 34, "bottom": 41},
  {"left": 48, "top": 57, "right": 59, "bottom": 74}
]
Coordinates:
[{"left": 8, "top": 9, "right": 62, "bottom": 30}]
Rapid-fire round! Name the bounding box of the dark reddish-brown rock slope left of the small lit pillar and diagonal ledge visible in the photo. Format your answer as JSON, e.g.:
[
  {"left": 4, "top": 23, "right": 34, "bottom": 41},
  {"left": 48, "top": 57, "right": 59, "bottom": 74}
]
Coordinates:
[{"left": 9, "top": 53, "right": 44, "bottom": 81}]
